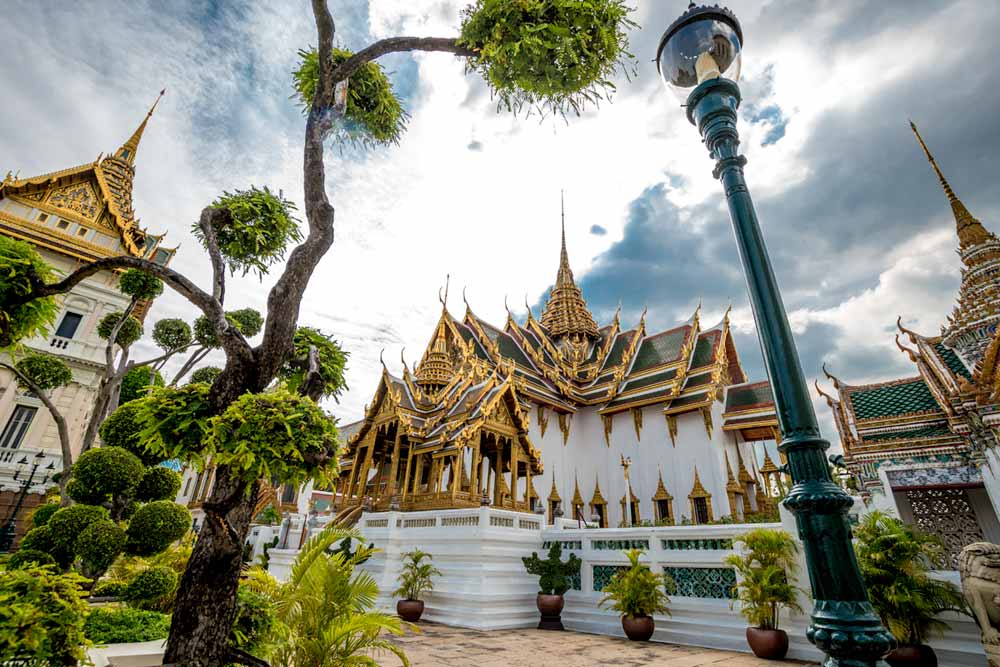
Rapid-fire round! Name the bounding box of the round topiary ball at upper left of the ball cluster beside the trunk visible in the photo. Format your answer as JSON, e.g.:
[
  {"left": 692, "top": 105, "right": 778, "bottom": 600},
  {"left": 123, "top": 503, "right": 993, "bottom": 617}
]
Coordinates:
[{"left": 66, "top": 446, "right": 144, "bottom": 506}]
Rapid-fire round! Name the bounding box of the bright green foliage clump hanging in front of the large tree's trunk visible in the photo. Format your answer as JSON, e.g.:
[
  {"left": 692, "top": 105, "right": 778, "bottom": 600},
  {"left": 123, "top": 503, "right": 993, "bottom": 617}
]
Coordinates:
[{"left": 205, "top": 388, "right": 337, "bottom": 485}]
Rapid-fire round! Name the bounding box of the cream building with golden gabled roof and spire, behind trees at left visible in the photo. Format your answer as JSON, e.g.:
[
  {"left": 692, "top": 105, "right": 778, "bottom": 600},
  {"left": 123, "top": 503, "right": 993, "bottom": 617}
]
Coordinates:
[{"left": 0, "top": 93, "right": 174, "bottom": 516}]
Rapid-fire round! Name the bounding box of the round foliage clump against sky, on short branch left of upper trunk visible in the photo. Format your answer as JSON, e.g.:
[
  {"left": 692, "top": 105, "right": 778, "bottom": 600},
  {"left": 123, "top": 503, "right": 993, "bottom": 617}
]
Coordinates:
[{"left": 197, "top": 186, "right": 302, "bottom": 276}]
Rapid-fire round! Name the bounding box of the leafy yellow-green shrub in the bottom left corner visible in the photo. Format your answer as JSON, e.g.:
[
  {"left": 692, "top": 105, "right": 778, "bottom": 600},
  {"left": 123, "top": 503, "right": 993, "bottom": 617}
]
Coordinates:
[{"left": 0, "top": 564, "right": 89, "bottom": 667}]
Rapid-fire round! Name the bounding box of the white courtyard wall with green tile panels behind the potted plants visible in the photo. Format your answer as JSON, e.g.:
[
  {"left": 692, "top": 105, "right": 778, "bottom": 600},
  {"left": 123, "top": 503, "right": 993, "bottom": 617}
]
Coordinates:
[{"left": 269, "top": 505, "right": 986, "bottom": 667}]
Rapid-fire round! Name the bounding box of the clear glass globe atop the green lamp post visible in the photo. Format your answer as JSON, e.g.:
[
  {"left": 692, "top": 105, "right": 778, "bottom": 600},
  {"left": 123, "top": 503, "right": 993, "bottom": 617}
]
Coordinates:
[{"left": 656, "top": 3, "right": 743, "bottom": 101}]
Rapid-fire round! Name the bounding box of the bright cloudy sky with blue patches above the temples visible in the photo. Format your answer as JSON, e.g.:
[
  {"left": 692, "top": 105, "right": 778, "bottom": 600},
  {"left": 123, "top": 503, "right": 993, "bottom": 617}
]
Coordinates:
[{"left": 0, "top": 0, "right": 1000, "bottom": 441}]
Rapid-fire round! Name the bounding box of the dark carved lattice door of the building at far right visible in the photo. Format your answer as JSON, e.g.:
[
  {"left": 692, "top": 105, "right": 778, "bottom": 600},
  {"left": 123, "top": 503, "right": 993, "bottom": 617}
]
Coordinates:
[{"left": 906, "top": 489, "right": 984, "bottom": 569}]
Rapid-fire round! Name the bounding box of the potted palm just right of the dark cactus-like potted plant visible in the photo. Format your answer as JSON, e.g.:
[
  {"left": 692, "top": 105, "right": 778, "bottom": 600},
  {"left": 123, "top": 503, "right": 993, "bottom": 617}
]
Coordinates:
[{"left": 598, "top": 549, "right": 673, "bottom": 642}]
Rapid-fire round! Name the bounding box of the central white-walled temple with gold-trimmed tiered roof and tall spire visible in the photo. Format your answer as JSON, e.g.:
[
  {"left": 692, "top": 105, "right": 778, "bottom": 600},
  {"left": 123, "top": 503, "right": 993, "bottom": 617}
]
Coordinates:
[{"left": 336, "top": 213, "right": 778, "bottom": 527}]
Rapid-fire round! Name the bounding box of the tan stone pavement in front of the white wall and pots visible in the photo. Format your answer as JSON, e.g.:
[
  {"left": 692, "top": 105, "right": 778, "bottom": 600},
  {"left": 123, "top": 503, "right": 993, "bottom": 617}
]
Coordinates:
[{"left": 376, "top": 623, "right": 806, "bottom": 667}]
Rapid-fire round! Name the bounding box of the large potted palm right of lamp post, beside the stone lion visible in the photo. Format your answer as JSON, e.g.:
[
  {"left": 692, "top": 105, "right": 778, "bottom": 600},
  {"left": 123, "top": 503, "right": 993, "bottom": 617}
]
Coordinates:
[{"left": 854, "top": 511, "right": 968, "bottom": 667}]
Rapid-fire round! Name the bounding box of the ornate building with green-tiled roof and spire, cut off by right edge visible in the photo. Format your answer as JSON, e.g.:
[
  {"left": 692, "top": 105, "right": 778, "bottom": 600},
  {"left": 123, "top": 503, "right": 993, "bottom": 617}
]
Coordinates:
[{"left": 817, "top": 126, "right": 1000, "bottom": 556}]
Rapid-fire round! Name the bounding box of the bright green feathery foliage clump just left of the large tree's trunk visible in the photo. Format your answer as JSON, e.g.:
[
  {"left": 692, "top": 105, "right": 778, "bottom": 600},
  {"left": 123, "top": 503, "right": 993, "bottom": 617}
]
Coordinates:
[{"left": 136, "top": 383, "right": 212, "bottom": 464}]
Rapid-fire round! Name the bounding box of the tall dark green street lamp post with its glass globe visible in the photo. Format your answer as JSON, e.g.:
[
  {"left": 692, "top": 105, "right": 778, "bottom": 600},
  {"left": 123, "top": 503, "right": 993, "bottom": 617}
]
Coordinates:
[{"left": 656, "top": 2, "right": 894, "bottom": 667}]
